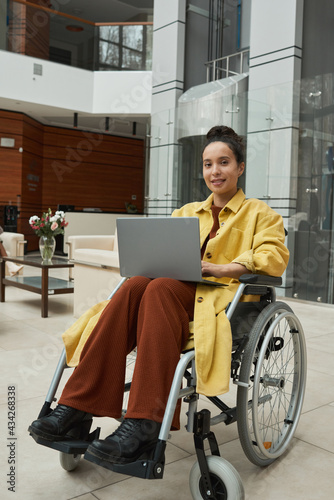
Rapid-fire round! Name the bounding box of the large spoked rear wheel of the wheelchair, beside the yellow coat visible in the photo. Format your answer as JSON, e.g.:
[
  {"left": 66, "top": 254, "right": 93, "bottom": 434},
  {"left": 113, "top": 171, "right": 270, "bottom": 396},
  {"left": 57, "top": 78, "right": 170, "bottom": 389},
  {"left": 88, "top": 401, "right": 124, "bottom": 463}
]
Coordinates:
[{"left": 237, "top": 302, "right": 306, "bottom": 466}]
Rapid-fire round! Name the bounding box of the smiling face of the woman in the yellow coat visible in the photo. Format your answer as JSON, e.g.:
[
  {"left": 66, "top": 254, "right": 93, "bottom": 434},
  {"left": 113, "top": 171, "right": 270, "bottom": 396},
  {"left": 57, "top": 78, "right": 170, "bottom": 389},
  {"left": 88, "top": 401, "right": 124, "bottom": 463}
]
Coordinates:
[{"left": 203, "top": 141, "right": 245, "bottom": 206}]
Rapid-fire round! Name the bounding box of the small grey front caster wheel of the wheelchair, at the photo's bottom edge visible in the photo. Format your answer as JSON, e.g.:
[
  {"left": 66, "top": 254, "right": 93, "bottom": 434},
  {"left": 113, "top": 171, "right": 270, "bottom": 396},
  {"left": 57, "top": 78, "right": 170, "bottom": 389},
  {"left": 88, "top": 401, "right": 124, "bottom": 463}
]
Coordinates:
[{"left": 189, "top": 455, "right": 245, "bottom": 500}]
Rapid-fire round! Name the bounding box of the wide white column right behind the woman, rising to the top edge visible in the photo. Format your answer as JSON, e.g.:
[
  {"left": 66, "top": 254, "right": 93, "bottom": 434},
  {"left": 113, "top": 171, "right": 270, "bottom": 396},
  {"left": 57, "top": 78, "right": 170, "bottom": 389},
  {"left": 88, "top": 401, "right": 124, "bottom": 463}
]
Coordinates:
[{"left": 246, "top": 0, "right": 304, "bottom": 295}]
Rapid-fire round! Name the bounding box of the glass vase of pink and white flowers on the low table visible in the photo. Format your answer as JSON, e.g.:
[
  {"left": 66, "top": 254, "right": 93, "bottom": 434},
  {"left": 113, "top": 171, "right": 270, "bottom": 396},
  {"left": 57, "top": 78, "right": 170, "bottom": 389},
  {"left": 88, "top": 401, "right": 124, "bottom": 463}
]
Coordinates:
[{"left": 29, "top": 208, "right": 68, "bottom": 264}]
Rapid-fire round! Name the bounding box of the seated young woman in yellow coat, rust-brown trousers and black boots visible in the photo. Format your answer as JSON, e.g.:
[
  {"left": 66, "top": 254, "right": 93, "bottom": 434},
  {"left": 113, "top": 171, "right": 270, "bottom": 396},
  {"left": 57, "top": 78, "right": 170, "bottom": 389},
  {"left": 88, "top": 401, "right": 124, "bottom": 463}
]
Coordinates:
[{"left": 29, "top": 126, "right": 289, "bottom": 463}]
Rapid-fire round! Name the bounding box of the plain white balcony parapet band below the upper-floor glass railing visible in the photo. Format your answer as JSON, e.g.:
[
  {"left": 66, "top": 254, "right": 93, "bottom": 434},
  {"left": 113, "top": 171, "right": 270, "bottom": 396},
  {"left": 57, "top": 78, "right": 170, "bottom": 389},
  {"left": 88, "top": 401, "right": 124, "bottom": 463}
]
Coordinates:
[{"left": 0, "top": 51, "right": 152, "bottom": 114}]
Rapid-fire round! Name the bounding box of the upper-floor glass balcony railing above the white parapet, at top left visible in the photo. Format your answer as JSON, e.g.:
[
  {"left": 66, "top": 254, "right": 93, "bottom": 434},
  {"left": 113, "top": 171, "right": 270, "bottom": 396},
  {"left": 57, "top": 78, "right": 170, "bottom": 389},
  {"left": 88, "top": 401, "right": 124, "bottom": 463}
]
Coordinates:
[{"left": 7, "top": 0, "right": 153, "bottom": 71}]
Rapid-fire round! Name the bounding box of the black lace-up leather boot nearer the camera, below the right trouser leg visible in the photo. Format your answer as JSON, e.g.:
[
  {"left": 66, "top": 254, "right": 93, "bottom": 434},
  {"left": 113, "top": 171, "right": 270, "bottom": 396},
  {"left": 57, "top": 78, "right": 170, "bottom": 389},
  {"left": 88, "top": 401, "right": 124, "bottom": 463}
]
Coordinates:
[{"left": 85, "top": 418, "right": 161, "bottom": 466}]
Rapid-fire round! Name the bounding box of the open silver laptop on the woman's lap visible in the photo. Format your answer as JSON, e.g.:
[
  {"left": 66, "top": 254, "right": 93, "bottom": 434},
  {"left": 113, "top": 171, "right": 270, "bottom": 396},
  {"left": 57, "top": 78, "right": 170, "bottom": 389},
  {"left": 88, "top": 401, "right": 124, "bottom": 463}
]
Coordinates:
[{"left": 116, "top": 217, "right": 226, "bottom": 286}]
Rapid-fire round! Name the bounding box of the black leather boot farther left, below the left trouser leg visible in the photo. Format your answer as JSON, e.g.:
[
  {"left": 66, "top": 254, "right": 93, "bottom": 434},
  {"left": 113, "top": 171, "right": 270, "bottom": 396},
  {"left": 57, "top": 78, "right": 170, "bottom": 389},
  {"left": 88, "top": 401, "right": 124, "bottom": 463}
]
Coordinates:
[{"left": 28, "top": 405, "right": 92, "bottom": 441}]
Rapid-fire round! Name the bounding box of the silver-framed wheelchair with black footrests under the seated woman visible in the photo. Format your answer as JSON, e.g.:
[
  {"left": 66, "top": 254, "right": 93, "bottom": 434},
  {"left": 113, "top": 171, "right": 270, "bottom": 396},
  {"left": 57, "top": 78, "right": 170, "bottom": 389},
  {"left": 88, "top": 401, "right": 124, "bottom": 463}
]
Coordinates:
[{"left": 31, "top": 274, "right": 307, "bottom": 500}]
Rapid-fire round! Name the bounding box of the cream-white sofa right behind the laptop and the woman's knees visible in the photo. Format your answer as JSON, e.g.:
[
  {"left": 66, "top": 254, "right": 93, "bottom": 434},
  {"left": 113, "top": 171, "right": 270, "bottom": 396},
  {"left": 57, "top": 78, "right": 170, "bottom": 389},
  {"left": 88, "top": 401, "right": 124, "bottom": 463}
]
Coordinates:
[{"left": 67, "top": 235, "right": 121, "bottom": 318}]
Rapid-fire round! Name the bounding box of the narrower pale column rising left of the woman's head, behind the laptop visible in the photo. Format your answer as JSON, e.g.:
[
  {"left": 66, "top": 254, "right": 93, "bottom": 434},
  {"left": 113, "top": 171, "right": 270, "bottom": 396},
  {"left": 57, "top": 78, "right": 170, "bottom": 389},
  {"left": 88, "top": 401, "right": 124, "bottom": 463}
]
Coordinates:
[{"left": 147, "top": 0, "right": 186, "bottom": 215}]
